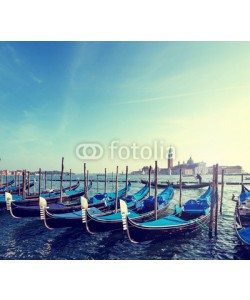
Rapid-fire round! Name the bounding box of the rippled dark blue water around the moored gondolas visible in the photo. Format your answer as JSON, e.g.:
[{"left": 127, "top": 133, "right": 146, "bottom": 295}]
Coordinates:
[{"left": 0, "top": 176, "right": 250, "bottom": 260}]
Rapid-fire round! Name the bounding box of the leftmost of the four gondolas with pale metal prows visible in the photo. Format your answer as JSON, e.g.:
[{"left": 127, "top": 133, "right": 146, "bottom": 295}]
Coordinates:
[{"left": 5, "top": 182, "right": 92, "bottom": 218}]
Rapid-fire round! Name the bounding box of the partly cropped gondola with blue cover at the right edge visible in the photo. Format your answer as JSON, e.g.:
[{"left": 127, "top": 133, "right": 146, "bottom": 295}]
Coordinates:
[{"left": 232, "top": 184, "right": 250, "bottom": 248}]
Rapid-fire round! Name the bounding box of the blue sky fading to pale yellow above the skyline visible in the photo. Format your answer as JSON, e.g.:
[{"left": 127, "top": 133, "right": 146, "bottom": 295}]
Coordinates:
[{"left": 0, "top": 41, "right": 250, "bottom": 173}]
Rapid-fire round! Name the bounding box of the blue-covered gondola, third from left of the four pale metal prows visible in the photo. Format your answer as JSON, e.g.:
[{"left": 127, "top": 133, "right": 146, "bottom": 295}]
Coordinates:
[{"left": 83, "top": 186, "right": 174, "bottom": 233}]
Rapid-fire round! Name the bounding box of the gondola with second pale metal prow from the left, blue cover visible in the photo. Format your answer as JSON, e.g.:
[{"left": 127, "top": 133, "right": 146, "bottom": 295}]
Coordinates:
[{"left": 40, "top": 185, "right": 139, "bottom": 229}]
